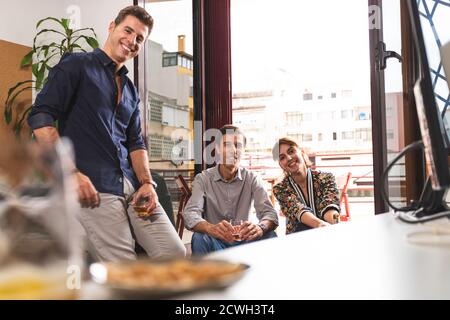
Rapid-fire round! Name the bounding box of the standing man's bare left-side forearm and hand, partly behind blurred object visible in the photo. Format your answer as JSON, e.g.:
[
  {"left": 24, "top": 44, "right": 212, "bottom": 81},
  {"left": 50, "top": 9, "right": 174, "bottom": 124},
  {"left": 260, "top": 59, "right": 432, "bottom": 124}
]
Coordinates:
[{"left": 33, "top": 127, "right": 100, "bottom": 208}]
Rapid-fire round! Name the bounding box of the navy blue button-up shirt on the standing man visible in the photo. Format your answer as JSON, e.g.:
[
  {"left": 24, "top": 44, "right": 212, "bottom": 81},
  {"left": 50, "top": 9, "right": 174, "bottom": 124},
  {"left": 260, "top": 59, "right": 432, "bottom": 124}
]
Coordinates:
[{"left": 28, "top": 49, "right": 146, "bottom": 195}]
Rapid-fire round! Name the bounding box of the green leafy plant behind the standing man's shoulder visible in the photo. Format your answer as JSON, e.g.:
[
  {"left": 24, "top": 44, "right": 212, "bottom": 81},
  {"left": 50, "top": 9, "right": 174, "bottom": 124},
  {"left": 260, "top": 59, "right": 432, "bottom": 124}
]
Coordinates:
[{"left": 4, "top": 17, "right": 98, "bottom": 136}]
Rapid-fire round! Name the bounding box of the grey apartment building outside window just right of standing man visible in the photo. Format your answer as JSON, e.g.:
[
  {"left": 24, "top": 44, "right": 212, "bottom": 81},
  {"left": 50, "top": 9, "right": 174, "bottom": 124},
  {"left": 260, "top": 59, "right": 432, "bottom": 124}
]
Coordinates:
[{"left": 146, "top": 36, "right": 194, "bottom": 176}]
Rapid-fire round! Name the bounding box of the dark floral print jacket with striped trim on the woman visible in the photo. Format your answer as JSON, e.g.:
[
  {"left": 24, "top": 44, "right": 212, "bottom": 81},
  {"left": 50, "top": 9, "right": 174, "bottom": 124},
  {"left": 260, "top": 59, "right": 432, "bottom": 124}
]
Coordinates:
[{"left": 273, "top": 169, "right": 340, "bottom": 234}]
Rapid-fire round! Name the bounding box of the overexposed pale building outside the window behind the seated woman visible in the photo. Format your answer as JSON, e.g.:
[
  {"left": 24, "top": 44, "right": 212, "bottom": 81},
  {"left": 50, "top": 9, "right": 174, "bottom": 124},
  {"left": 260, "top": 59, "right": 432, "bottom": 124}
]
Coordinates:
[{"left": 233, "top": 89, "right": 373, "bottom": 197}]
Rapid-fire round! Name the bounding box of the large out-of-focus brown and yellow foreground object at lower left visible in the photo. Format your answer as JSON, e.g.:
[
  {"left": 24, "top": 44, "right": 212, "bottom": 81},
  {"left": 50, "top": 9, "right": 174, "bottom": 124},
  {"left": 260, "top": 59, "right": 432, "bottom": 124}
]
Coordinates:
[{"left": 0, "top": 132, "right": 84, "bottom": 299}]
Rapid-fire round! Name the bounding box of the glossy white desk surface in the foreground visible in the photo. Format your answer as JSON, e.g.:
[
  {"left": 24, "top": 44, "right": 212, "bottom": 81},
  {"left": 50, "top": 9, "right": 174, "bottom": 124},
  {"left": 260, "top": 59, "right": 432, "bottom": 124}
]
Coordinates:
[{"left": 180, "top": 214, "right": 450, "bottom": 300}]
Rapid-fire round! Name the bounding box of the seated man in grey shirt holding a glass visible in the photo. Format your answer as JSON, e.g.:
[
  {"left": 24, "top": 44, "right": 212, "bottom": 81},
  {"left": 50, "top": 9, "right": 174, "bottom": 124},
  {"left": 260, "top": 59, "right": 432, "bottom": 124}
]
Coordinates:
[{"left": 183, "top": 125, "right": 278, "bottom": 254}]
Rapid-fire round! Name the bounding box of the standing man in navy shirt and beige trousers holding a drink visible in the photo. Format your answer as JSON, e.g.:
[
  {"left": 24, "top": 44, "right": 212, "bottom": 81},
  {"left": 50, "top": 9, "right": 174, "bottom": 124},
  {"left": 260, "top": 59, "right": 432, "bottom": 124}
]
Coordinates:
[{"left": 28, "top": 6, "right": 186, "bottom": 261}]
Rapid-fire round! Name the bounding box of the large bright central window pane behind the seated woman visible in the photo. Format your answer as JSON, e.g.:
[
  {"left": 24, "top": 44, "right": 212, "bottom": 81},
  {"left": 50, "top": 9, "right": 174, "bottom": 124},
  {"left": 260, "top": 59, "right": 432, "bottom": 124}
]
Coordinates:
[{"left": 230, "top": 0, "right": 374, "bottom": 220}]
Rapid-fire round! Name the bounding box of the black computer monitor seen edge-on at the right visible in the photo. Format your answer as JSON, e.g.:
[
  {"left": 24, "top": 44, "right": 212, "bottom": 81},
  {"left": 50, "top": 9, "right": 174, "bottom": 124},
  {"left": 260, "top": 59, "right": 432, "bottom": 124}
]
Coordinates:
[{"left": 407, "top": 0, "right": 450, "bottom": 190}]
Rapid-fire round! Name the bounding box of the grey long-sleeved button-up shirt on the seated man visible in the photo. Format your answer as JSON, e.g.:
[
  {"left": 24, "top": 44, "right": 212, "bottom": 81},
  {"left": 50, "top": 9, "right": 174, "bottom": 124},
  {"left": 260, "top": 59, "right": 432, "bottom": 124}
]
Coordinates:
[{"left": 183, "top": 165, "right": 278, "bottom": 230}]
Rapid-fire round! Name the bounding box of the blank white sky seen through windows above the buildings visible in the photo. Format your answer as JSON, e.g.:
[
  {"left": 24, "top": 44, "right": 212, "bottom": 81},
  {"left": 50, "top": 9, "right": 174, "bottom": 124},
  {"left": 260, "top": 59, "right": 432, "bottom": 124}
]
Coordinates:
[{"left": 147, "top": 0, "right": 401, "bottom": 101}]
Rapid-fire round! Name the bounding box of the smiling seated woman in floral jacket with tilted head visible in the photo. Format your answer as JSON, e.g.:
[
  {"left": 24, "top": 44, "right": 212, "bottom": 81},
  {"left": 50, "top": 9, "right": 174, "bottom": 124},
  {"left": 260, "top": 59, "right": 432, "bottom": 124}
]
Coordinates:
[{"left": 272, "top": 137, "right": 340, "bottom": 234}]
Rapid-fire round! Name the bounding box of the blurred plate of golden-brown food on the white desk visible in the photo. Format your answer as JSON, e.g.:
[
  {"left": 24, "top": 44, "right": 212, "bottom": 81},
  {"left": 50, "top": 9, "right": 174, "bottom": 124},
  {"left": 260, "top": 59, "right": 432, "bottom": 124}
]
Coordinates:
[{"left": 89, "top": 258, "right": 249, "bottom": 299}]
